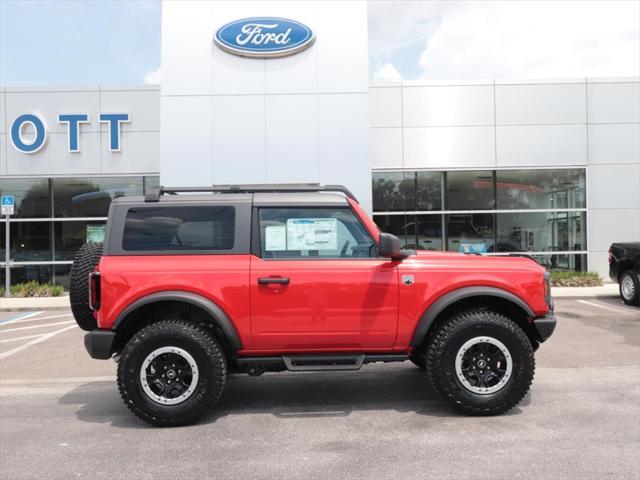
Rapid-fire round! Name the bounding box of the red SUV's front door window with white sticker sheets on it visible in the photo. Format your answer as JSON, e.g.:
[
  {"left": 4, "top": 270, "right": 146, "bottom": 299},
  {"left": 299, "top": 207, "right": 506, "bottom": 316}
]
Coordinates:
[{"left": 259, "top": 208, "right": 377, "bottom": 258}]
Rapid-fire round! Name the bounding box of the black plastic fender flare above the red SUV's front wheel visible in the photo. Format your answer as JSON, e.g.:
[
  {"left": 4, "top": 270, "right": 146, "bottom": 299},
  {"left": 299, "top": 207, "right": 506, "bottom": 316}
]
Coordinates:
[{"left": 411, "top": 287, "right": 535, "bottom": 347}]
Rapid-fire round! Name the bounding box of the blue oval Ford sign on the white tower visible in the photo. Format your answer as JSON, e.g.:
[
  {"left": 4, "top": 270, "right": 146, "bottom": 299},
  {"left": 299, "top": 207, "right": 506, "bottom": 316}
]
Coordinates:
[{"left": 215, "top": 17, "right": 315, "bottom": 58}]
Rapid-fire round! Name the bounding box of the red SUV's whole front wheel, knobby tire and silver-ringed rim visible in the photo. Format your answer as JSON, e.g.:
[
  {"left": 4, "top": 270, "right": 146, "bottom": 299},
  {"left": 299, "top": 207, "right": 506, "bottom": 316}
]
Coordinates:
[{"left": 426, "top": 310, "right": 535, "bottom": 415}]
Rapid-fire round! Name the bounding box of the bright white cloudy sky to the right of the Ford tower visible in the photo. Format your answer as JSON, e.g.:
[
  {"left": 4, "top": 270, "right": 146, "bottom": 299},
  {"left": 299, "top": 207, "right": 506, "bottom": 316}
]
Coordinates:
[{"left": 369, "top": 1, "right": 640, "bottom": 79}]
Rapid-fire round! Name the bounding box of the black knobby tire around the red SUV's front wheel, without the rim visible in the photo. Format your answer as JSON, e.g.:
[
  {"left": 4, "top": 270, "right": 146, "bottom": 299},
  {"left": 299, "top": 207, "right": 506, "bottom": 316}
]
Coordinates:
[{"left": 426, "top": 310, "right": 535, "bottom": 415}]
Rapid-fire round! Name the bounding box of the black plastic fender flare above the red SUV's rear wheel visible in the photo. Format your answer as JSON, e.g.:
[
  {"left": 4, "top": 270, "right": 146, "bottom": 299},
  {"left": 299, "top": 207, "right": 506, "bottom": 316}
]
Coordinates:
[{"left": 112, "top": 290, "right": 242, "bottom": 350}]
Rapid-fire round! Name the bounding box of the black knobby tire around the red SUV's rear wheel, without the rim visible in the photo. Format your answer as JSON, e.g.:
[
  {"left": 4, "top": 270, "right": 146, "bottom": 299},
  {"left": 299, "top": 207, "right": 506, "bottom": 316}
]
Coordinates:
[{"left": 118, "top": 320, "right": 227, "bottom": 427}]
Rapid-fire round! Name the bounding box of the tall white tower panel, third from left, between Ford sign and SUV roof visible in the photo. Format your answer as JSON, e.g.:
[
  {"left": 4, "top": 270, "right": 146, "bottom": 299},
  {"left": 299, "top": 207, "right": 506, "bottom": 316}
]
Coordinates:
[{"left": 264, "top": 95, "right": 319, "bottom": 183}]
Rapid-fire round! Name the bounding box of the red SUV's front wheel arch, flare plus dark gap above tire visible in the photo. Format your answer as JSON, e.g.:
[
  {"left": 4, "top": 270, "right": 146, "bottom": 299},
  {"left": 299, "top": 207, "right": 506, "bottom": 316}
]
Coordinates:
[{"left": 411, "top": 286, "right": 538, "bottom": 347}]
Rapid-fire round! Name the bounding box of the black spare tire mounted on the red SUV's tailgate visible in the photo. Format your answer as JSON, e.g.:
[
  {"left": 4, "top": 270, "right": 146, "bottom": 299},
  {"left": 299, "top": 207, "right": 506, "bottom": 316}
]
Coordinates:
[{"left": 69, "top": 243, "right": 102, "bottom": 330}]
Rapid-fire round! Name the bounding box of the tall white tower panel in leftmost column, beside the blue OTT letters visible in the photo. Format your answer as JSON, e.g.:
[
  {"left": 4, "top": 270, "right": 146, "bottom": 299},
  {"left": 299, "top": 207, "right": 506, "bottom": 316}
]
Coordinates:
[{"left": 160, "top": 96, "right": 213, "bottom": 186}]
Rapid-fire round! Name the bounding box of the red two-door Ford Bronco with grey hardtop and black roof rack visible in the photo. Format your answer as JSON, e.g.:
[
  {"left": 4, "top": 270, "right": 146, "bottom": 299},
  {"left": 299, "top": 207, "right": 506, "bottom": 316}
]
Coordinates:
[{"left": 71, "top": 184, "right": 556, "bottom": 426}]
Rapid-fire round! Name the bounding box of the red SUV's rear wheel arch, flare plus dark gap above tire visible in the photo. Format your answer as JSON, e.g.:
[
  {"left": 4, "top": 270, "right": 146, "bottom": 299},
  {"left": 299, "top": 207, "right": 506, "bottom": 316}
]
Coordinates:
[{"left": 112, "top": 290, "right": 242, "bottom": 351}]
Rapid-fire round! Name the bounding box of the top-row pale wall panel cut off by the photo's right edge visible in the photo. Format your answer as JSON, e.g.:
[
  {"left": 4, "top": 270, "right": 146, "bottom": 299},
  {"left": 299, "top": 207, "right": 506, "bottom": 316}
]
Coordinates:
[{"left": 587, "top": 83, "right": 640, "bottom": 123}]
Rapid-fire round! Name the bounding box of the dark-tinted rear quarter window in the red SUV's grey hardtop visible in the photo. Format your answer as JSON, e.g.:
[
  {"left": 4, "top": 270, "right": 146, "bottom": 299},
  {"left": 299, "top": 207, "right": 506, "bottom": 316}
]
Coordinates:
[{"left": 122, "top": 206, "right": 235, "bottom": 251}]
